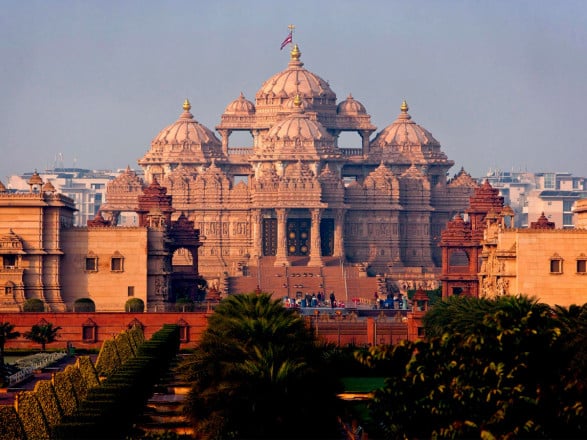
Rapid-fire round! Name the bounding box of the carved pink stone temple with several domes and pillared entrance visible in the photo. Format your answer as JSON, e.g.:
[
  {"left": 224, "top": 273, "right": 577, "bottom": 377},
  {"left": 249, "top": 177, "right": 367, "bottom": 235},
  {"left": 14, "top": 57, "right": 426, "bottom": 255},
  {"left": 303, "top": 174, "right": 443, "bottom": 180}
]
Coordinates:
[{"left": 102, "top": 45, "right": 476, "bottom": 294}]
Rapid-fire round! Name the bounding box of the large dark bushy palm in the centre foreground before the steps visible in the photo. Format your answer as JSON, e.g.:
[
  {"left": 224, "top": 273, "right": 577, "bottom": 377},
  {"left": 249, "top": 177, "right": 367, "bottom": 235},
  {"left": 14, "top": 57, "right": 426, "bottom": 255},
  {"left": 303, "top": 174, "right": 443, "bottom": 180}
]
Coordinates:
[{"left": 181, "top": 293, "right": 339, "bottom": 439}]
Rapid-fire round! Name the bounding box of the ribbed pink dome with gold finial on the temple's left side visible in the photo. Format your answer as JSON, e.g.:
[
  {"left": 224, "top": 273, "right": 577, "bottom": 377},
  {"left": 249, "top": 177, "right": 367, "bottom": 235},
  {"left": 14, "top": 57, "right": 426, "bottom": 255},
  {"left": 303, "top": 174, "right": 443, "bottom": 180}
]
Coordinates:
[{"left": 151, "top": 99, "right": 221, "bottom": 147}]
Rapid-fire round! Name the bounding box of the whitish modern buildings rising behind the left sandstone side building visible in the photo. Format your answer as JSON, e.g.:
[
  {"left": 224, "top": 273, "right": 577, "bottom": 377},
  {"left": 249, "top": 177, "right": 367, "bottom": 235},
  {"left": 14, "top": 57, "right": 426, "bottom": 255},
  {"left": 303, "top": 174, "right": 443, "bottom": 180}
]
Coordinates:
[{"left": 6, "top": 168, "right": 145, "bottom": 226}]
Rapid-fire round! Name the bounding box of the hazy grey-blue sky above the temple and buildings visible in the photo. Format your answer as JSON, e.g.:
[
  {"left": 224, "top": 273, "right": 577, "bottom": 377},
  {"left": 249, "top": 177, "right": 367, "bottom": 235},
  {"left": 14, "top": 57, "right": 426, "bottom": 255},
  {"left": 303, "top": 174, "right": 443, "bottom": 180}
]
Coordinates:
[{"left": 0, "top": 0, "right": 587, "bottom": 183}]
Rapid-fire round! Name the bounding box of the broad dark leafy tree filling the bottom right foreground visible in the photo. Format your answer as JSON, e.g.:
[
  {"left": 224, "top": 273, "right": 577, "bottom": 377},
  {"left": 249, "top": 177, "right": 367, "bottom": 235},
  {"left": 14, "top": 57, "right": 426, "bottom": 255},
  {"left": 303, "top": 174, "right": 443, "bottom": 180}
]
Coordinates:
[{"left": 361, "top": 296, "right": 587, "bottom": 439}]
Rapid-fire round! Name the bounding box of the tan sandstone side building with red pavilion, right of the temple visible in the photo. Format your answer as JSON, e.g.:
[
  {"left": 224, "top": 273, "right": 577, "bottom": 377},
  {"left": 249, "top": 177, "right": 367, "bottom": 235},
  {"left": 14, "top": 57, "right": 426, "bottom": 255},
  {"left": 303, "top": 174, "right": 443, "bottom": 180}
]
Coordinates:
[{"left": 440, "top": 181, "right": 587, "bottom": 306}]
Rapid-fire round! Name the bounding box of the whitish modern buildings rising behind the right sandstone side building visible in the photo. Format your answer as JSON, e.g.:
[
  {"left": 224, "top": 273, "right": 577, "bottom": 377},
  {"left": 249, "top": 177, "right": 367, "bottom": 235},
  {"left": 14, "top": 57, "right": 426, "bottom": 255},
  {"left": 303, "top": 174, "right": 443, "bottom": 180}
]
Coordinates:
[{"left": 483, "top": 170, "right": 587, "bottom": 228}]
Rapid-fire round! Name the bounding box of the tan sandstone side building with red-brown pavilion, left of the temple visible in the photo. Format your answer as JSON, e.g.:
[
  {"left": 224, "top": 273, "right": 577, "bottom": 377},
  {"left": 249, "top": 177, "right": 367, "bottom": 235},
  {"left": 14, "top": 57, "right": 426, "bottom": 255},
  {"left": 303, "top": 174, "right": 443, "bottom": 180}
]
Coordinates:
[{"left": 0, "top": 173, "right": 201, "bottom": 312}]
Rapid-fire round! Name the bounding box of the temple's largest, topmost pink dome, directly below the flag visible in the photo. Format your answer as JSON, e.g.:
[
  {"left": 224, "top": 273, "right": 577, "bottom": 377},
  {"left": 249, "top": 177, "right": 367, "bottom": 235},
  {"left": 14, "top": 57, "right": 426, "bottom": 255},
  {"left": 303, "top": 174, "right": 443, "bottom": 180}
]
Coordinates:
[{"left": 255, "top": 44, "right": 336, "bottom": 113}]
